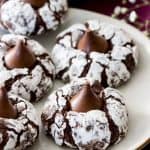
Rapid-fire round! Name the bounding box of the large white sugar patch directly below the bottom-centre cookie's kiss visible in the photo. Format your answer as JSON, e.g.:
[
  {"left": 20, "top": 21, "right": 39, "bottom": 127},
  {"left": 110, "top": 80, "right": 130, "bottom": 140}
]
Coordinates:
[{"left": 67, "top": 110, "right": 111, "bottom": 149}]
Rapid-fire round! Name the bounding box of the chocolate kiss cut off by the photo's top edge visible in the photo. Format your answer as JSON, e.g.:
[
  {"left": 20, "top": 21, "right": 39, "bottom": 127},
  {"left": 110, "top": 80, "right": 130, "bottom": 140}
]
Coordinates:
[{"left": 24, "top": 0, "right": 47, "bottom": 8}]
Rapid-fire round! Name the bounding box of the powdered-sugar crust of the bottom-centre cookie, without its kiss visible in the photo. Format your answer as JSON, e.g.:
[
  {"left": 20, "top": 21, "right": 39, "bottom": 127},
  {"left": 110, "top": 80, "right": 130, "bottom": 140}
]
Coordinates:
[{"left": 42, "top": 78, "right": 128, "bottom": 150}]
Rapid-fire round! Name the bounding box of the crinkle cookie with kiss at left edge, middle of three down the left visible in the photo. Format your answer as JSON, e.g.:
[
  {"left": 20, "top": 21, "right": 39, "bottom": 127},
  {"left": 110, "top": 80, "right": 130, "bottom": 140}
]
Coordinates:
[{"left": 0, "top": 34, "right": 55, "bottom": 102}]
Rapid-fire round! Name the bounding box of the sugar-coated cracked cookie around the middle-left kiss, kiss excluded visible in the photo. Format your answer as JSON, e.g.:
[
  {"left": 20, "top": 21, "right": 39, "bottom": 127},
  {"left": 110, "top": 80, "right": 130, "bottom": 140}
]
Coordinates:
[{"left": 0, "top": 34, "right": 55, "bottom": 101}]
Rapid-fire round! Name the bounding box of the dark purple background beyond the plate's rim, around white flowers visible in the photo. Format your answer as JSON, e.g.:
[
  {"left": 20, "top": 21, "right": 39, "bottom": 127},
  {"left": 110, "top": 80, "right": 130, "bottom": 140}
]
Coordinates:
[{"left": 69, "top": 0, "right": 150, "bottom": 150}]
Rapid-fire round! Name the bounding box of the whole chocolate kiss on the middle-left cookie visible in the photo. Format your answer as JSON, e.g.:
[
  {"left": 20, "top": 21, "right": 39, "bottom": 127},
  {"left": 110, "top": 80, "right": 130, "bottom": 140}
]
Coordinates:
[{"left": 5, "top": 40, "right": 36, "bottom": 69}]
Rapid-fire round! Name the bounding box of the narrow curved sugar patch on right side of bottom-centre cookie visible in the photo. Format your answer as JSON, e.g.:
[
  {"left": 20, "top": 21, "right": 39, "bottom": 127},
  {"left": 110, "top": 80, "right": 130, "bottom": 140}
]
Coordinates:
[{"left": 105, "top": 88, "right": 128, "bottom": 141}]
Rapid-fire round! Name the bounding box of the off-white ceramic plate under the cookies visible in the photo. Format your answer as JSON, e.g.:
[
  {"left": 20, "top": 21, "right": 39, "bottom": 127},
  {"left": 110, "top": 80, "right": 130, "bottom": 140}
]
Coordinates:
[{"left": 0, "top": 9, "right": 150, "bottom": 150}]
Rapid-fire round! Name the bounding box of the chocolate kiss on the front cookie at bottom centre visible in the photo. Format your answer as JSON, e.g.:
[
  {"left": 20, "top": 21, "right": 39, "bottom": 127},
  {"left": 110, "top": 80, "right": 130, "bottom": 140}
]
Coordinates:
[{"left": 70, "top": 84, "right": 103, "bottom": 112}]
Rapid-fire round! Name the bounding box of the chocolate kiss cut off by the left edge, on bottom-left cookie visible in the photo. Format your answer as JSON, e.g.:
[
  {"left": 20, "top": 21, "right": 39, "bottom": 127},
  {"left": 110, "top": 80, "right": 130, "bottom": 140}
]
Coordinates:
[{"left": 0, "top": 87, "right": 17, "bottom": 119}]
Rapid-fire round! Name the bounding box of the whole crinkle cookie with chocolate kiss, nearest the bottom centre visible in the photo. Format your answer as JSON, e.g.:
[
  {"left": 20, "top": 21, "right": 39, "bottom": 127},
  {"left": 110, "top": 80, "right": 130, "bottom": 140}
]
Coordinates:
[{"left": 41, "top": 78, "right": 128, "bottom": 150}]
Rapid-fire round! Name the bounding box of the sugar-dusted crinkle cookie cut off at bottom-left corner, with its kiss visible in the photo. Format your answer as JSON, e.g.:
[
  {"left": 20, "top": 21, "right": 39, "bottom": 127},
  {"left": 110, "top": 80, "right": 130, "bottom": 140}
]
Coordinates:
[{"left": 0, "top": 87, "right": 39, "bottom": 150}]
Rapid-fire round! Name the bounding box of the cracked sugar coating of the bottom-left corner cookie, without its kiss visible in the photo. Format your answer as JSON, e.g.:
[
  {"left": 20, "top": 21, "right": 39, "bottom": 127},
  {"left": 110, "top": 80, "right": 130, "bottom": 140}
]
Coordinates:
[{"left": 0, "top": 94, "right": 39, "bottom": 150}]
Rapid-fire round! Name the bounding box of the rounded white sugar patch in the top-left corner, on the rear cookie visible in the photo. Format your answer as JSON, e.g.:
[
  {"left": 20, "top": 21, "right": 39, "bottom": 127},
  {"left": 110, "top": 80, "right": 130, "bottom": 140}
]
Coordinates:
[{"left": 1, "top": 0, "right": 36, "bottom": 34}]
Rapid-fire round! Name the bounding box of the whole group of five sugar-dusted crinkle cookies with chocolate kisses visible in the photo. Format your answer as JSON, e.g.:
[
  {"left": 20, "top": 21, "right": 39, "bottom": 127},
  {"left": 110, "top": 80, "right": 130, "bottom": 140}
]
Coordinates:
[{"left": 0, "top": 0, "right": 138, "bottom": 150}]
